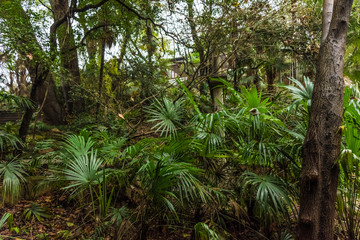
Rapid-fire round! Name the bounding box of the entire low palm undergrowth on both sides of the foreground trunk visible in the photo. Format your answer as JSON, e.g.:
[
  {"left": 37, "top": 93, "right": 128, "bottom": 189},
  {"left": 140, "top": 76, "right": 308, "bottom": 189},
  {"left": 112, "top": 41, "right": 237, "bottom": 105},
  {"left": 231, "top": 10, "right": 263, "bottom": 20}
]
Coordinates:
[{"left": 0, "top": 78, "right": 360, "bottom": 239}]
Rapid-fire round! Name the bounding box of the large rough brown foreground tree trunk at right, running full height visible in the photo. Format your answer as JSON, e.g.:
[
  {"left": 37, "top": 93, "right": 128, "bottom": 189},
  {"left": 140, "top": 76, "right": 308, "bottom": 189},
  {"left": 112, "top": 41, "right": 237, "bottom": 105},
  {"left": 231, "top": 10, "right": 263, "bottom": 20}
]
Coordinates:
[{"left": 298, "top": 0, "right": 353, "bottom": 240}]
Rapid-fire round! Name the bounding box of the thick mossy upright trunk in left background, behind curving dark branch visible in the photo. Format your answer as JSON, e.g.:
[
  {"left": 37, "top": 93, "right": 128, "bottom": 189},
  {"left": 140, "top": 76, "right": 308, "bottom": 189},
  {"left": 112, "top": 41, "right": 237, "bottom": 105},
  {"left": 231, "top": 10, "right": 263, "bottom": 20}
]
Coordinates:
[{"left": 50, "top": 0, "right": 83, "bottom": 114}]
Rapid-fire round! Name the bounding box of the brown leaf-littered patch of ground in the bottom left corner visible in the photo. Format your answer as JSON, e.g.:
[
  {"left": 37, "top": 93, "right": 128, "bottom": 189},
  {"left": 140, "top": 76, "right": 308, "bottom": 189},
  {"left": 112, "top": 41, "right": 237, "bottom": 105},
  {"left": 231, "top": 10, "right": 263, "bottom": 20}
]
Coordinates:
[{"left": 0, "top": 191, "right": 95, "bottom": 240}]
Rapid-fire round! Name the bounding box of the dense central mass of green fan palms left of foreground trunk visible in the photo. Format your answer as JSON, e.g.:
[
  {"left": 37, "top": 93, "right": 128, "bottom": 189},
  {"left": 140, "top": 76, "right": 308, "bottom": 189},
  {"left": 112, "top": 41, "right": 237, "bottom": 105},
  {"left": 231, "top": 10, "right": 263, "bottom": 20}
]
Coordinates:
[{"left": 51, "top": 80, "right": 330, "bottom": 239}]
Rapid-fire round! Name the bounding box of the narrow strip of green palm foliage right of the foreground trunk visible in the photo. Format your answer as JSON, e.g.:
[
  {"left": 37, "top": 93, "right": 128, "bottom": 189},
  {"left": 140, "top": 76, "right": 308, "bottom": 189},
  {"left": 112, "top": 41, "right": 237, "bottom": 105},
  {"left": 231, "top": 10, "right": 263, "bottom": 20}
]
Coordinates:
[{"left": 336, "top": 91, "right": 360, "bottom": 239}]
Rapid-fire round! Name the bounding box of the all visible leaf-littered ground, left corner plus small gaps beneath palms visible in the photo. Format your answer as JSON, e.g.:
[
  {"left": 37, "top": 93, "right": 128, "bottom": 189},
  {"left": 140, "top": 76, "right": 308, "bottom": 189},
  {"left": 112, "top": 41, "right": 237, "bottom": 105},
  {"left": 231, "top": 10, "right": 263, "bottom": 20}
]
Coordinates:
[{"left": 0, "top": 190, "right": 264, "bottom": 240}]
